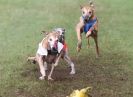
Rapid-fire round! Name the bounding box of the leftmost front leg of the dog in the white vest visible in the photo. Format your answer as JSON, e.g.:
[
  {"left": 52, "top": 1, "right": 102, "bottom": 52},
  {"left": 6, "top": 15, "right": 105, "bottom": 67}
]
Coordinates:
[{"left": 37, "top": 55, "right": 46, "bottom": 80}]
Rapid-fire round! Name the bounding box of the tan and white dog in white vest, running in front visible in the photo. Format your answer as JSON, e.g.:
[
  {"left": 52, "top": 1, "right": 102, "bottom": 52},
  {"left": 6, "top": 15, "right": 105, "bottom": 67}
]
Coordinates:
[{"left": 28, "top": 29, "right": 75, "bottom": 80}]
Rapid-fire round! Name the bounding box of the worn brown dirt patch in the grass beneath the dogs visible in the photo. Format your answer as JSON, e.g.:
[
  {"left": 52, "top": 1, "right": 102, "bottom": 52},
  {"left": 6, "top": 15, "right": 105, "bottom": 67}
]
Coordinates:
[{"left": 21, "top": 53, "right": 133, "bottom": 97}]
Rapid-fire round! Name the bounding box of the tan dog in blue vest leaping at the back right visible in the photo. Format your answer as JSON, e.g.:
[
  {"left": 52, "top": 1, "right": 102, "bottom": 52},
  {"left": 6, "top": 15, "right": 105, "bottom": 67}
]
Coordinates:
[{"left": 76, "top": 2, "right": 99, "bottom": 57}]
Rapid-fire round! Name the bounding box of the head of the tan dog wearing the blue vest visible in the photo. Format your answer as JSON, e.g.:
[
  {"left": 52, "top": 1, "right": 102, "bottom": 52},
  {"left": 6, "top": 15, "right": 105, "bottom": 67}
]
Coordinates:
[{"left": 80, "top": 1, "right": 94, "bottom": 20}]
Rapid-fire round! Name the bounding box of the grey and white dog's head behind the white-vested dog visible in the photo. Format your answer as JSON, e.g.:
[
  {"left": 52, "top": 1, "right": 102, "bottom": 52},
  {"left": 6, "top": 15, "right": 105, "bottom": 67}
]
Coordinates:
[{"left": 53, "top": 28, "right": 65, "bottom": 43}]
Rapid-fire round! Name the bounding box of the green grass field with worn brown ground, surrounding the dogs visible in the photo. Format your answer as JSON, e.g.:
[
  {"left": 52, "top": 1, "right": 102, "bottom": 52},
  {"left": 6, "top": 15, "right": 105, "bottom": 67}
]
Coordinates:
[{"left": 0, "top": 0, "right": 133, "bottom": 97}]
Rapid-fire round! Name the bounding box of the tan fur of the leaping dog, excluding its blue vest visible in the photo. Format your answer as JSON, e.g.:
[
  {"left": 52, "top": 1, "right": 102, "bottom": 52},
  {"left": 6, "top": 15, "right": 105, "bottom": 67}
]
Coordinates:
[{"left": 76, "top": 3, "right": 99, "bottom": 57}]
